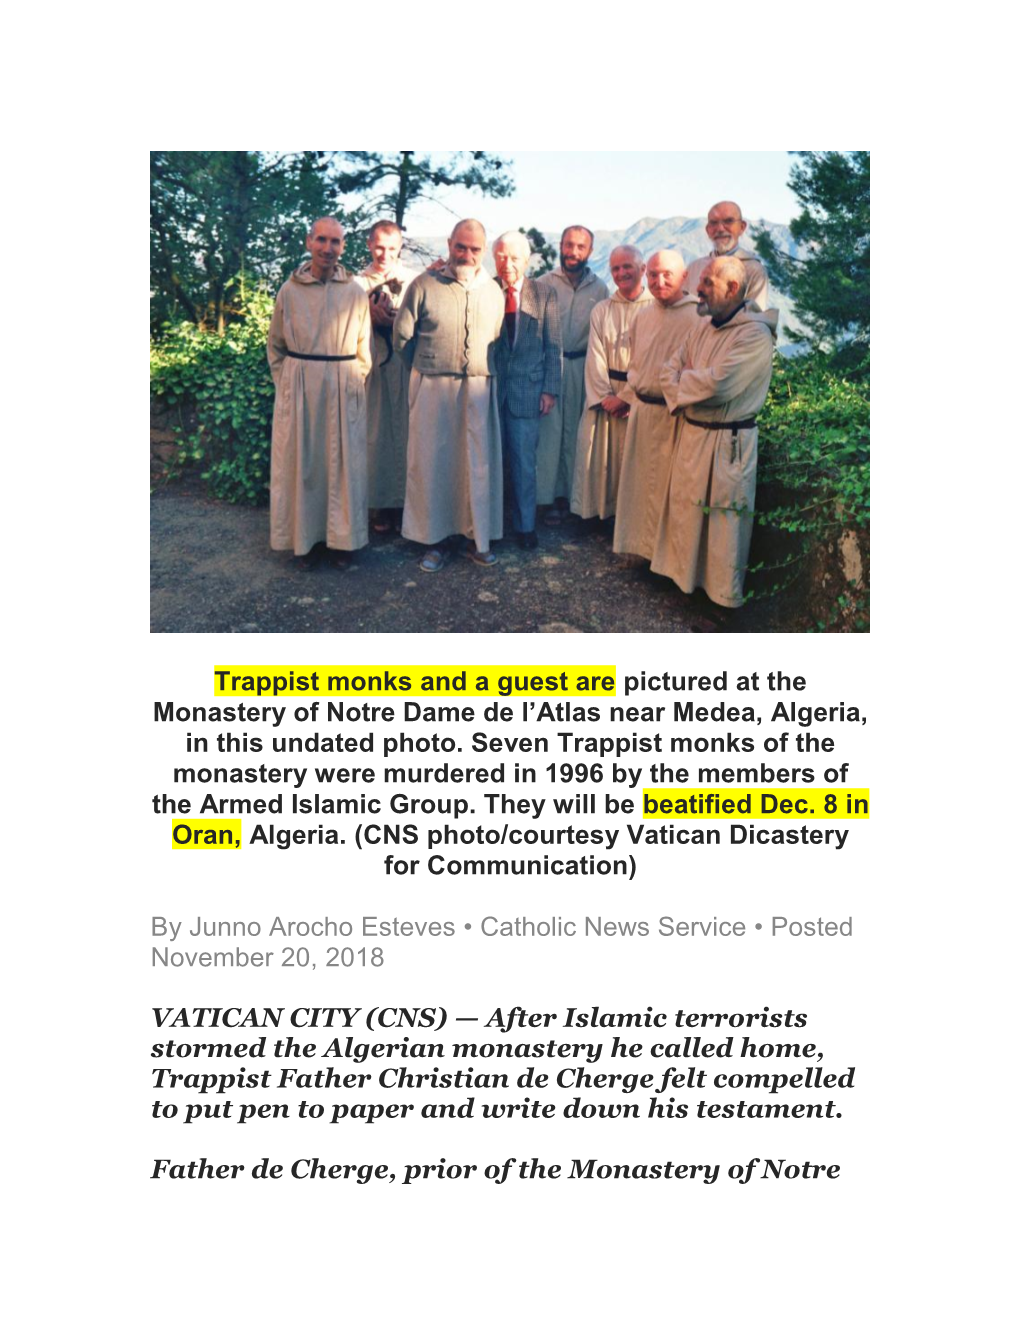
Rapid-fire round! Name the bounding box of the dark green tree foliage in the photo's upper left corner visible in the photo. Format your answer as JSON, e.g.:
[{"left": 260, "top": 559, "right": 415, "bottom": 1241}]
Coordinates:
[{"left": 149, "top": 152, "right": 364, "bottom": 334}]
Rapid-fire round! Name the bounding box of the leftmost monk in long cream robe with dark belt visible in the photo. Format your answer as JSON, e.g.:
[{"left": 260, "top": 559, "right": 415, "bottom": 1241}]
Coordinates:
[{"left": 268, "top": 219, "right": 372, "bottom": 568}]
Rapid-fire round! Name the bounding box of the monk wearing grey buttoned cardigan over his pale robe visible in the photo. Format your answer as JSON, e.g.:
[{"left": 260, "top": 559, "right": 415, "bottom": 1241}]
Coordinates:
[{"left": 393, "top": 220, "right": 504, "bottom": 573}]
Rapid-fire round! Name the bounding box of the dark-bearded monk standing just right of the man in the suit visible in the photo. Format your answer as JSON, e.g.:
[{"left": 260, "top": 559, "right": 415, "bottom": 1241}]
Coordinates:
[{"left": 537, "top": 224, "right": 610, "bottom": 525}]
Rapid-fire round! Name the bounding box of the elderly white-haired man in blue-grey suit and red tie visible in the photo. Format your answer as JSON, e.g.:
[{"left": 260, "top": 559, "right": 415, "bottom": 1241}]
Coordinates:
[{"left": 492, "top": 231, "right": 562, "bottom": 550}]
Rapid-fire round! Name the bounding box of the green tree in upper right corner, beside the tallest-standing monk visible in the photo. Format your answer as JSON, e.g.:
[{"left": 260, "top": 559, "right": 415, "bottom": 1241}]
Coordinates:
[{"left": 753, "top": 152, "right": 871, "bottom": 370}]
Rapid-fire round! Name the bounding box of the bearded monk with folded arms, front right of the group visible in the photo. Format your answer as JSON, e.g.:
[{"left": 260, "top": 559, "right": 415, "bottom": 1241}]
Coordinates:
[{"left": 652, "top": 257, "right": 779, "bottom": 609}]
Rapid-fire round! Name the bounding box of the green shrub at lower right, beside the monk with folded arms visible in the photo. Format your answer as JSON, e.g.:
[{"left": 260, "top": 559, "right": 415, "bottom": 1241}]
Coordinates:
[{"left": 751, "top": 352, "right": 871, "bottom": 627}]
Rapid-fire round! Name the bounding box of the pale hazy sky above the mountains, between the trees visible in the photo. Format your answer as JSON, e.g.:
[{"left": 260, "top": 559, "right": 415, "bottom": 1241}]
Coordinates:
[{"left": 398, "top": 150, "right": 800, "bottom": 235}]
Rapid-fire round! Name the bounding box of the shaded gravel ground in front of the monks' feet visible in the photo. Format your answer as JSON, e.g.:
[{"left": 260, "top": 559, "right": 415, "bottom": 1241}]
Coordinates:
[{"left": 150, "top": 482, "right": 796, "bottom": 632}]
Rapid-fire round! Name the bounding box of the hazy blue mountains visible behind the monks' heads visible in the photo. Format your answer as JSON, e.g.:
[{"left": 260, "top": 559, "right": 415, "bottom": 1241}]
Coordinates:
[{"left": 406, "top": 215, "right": 798, "bottom": 343}]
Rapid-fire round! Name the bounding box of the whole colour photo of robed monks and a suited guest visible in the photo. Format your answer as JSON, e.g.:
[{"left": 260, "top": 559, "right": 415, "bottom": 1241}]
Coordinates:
[{"left": 150, "top": 152, "right": 870, "bottom": 632}]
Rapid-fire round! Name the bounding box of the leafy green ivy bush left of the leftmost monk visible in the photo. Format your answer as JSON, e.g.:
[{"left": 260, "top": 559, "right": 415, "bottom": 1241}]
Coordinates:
[{"left": 149, "top": 290, "right": 273, "bottom": 504}]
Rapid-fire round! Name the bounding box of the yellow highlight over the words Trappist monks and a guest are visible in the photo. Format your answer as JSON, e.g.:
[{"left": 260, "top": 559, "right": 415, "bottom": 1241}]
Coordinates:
[{"left": 212, "top": 664, "right": 616, "bottom": 697}]
